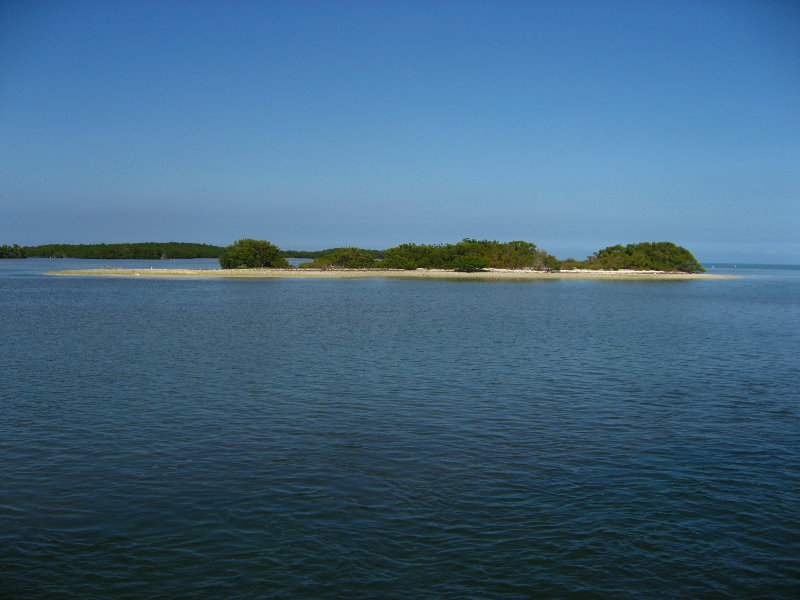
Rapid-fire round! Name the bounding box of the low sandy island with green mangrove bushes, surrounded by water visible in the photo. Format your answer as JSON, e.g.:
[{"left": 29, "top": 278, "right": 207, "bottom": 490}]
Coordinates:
[{"left": 42, "top": 238, "right": 731, "bottom": 280}]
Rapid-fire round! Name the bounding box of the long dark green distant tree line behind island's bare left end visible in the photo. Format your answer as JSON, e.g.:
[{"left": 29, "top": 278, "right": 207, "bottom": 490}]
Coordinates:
[{"left": 25, "top": 242, "right": 223, "bottom": 259}]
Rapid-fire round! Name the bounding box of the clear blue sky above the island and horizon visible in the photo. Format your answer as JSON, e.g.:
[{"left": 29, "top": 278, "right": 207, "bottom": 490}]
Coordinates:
[{"left": 0, "top": 0, "right": 800, "bottom": 263}]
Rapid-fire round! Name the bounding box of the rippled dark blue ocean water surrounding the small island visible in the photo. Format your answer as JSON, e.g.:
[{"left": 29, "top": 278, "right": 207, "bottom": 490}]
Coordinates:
[{"left": 0, "top": 259, "right": 800, "bottom": 599}]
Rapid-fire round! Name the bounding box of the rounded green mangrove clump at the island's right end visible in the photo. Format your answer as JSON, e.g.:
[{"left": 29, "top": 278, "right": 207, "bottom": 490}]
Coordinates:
[{"left": 563, "top": 242, "right": 705, "bottom": 273}]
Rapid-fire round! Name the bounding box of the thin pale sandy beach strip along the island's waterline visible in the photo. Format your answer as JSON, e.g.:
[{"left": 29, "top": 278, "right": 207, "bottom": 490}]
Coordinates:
[{"left": 47, "top": 268, "right": 734, "bottom": 280}]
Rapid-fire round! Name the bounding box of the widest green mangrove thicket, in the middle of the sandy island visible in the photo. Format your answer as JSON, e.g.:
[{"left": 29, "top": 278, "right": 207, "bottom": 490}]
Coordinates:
[{"left": 381, "top": 239, "right": 561, "bottom": 271}]
